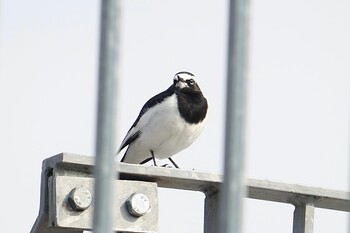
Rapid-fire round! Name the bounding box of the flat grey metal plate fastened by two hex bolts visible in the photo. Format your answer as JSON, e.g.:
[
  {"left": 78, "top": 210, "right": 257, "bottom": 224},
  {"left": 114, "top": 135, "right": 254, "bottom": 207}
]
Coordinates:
[{"left": 50, "top": 176, "right": 159, "bottom": 233}]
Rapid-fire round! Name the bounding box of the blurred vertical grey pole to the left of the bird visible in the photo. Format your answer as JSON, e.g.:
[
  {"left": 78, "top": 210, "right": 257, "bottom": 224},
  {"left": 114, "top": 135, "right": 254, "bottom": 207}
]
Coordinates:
[{"left": 93, "top": 0, "right": 119, "bottom": 233}]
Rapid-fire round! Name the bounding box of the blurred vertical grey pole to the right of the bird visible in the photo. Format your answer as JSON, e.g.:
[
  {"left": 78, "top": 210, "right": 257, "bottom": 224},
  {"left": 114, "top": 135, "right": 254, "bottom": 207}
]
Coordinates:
[{"left": 220, "top": 0, "right": 248, "bottom": 233}]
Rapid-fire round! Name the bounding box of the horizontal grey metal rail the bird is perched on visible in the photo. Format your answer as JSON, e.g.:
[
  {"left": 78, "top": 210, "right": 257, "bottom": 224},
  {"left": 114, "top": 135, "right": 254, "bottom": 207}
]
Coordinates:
[{"left": 45, "top": 153, "right": 350, "bottom": 212}]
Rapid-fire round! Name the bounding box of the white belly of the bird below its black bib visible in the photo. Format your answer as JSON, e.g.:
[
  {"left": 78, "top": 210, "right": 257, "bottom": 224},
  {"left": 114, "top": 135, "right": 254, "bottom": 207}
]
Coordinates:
[{"left": 124, "top": 96, "right": 203, "bottom": 163}]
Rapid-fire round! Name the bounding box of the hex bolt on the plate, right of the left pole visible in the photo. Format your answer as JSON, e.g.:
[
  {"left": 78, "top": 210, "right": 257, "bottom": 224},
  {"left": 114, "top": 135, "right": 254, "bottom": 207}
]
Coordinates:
[{"left": 125, "top": 193, "right": 151, "bottom": 217}]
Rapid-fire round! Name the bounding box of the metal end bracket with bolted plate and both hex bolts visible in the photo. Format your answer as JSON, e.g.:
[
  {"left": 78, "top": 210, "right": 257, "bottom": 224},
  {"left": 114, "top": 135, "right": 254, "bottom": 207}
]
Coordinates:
[{"left": 31, "top": 154, "right": 159, "bottom": 233}]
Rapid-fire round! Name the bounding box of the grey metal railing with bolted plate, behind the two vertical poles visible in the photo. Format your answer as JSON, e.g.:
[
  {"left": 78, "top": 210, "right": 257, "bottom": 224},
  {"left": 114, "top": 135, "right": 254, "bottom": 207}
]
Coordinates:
[{"left": 31, "top": 153, "right": 350, "bottom": 233}]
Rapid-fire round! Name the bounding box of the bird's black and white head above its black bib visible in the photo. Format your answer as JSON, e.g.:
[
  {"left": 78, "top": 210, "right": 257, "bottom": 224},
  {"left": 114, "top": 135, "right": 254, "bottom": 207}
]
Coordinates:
[{"left": 174, "top": 71, "right": 201, "bottom": 93}]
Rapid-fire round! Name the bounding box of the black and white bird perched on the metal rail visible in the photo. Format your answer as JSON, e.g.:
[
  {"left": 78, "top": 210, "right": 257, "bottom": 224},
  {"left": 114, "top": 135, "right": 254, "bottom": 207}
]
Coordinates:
[{"left": 118, "top": 72, "right": 208, "bottom": 168}]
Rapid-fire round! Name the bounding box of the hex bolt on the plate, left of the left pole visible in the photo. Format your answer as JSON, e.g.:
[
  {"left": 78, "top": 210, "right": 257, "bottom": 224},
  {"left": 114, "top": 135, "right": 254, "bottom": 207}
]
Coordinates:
[{"left": 68, "top": 187, "right": 92, "bottom": 211}]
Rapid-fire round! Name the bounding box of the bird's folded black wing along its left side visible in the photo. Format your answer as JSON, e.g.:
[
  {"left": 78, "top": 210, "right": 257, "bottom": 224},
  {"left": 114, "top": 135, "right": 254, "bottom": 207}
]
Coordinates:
[{"left": 118, "top": 85, "right": 174, "bottom": 153}]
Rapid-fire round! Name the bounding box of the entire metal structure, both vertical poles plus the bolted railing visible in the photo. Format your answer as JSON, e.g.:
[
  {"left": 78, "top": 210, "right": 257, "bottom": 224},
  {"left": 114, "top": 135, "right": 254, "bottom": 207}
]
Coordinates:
[{"left": 31, "top": 0, "right": 350, "bottom": 233}]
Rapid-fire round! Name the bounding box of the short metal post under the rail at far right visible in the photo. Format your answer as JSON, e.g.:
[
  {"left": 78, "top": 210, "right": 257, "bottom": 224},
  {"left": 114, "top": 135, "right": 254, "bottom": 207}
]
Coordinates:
[{"left": 293, "top": 203, "right": 315, "bottom": 233}]
